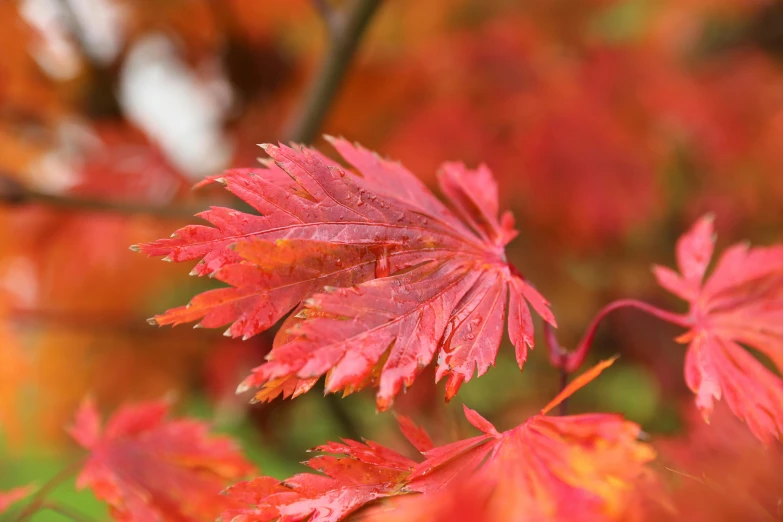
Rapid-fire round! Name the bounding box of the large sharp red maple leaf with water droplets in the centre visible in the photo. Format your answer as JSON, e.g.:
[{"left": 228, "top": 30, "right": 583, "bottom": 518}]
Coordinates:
[{"left": 139, "top": 138, "right": 555, "bottom": 410}]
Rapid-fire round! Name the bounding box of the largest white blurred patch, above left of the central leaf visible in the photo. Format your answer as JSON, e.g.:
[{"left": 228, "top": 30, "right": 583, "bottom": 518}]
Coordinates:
[{"left": 119, "top": 35, "right": 232, "bottom": 179}]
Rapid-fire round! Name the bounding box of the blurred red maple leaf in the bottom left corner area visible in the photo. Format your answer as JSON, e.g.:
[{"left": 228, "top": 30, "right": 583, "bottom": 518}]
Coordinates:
[{"left": 69, "top": 400, "right": 254, "bottom": 522}]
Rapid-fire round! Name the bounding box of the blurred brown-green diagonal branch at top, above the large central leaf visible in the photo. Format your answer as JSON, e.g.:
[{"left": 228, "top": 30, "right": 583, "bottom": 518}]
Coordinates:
[{"left": 283, "top": 0, "right": 381, "bottom": 143}]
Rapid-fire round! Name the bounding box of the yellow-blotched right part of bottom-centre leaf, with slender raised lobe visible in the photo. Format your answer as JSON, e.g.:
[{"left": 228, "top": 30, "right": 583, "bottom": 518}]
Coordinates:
[{"left": 406, "top": 359, "right": 654, "bottom": 521}]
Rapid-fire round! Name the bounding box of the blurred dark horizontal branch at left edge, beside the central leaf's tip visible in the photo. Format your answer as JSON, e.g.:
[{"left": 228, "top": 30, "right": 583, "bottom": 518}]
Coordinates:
[{"left": 0, "top": 174, "right": 199, "bottom": 219}]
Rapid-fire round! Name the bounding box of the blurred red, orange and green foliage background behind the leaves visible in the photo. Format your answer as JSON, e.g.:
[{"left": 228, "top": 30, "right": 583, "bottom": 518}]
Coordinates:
[{"left": 0, "top": 0, "right": 783, "bottom": 521}]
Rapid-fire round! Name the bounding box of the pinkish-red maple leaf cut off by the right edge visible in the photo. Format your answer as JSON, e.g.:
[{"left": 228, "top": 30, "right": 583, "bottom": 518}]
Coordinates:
[{"left": 654, "top": 216, "right": 783, "bottom": 443}]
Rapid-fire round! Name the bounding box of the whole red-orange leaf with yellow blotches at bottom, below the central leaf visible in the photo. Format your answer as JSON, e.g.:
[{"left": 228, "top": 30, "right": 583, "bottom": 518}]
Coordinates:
[{"left": 222, "top": 360, "right": 654, "bottom": 522}]
